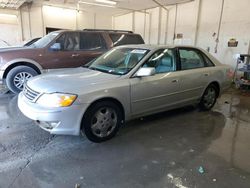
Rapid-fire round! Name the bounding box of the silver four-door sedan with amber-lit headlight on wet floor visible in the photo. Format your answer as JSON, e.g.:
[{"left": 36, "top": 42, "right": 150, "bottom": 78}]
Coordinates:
[{"left": 18, "top": 45, "right": 231, "bottom": 142}]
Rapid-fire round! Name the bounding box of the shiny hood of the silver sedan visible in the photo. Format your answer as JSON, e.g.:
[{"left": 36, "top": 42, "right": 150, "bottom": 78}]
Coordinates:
[{"left": 27, "top": 67, "right": 121, "bottom": 94}]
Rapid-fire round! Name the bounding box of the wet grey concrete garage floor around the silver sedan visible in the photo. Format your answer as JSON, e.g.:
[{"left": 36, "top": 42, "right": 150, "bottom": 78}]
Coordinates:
[{"left": 0, "top": 88, "right": 250, "bottom": 188}]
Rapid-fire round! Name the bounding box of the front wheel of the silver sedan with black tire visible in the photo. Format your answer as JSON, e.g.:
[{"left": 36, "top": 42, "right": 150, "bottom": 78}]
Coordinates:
[{"left": 81, "top": 101, "right": 122, "bottom": 143}]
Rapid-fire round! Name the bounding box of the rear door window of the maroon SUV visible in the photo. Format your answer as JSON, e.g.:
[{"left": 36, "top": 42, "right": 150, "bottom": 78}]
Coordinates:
[{"left": 80, "top": 33, "right": 106, "bottom": 50}]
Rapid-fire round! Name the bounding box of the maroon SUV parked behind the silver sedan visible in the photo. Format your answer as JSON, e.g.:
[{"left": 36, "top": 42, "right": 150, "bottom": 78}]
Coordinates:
[{"left": 0, "top": 29, "right": 144, "bottom": 93}]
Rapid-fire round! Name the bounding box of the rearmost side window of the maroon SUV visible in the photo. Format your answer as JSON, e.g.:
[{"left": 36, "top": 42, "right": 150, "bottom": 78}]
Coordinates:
[{"left": 109, "top": 33, "right": 144, "bottom": 46}]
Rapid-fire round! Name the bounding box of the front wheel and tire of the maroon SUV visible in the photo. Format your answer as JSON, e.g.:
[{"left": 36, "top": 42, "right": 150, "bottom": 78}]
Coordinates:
[{"left": 6, "top": 66, "right": 38, "bottom": 93}]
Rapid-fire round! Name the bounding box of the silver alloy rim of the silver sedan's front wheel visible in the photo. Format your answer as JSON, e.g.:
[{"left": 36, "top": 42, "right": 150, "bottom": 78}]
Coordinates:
[{"left": 91, "top": 107, "right": 117, "bottom": 138}]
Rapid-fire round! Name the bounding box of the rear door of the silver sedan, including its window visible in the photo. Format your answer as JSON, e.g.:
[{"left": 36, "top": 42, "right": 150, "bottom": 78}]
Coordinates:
[{"left": 178, "top": 48, "right": 213, "bottom": 102}]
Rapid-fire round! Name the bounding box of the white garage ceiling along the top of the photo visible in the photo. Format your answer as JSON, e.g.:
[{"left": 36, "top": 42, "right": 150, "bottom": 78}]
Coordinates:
[{"left": 0, "top": 0, "right": 193, "bottom": 14}]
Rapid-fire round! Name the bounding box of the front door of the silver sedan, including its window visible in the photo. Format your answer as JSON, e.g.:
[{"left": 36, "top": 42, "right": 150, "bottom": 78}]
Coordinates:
[{"left": 130, "top": 49, "right": 180, "bottom": 116}]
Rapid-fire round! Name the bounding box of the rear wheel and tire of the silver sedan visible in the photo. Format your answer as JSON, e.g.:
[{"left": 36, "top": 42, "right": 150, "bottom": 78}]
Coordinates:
[{"left": 199, "top": 84, "right": 218, "bottom": 111}]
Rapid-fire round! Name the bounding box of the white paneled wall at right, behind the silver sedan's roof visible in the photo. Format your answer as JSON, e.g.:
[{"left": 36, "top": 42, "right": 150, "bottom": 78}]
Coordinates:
[{"left": 113, "top": 0, "right": 250, "bottom": 66}]
